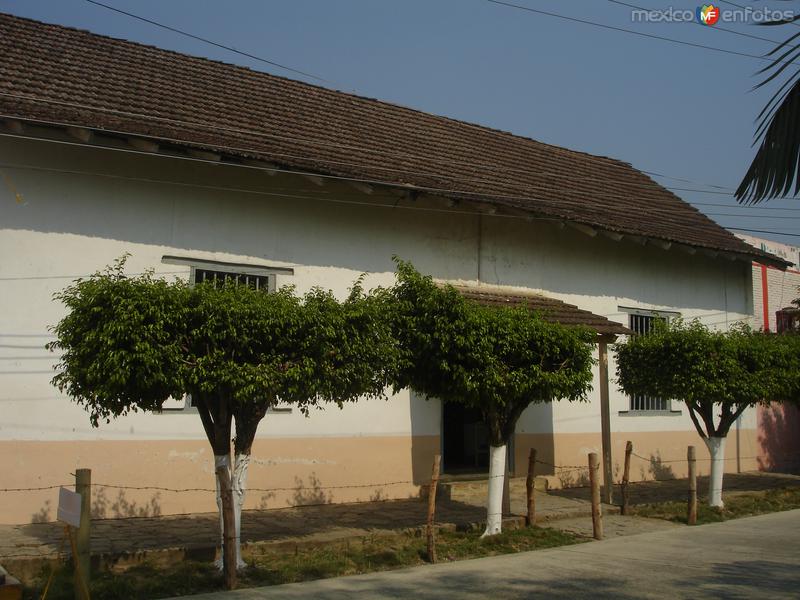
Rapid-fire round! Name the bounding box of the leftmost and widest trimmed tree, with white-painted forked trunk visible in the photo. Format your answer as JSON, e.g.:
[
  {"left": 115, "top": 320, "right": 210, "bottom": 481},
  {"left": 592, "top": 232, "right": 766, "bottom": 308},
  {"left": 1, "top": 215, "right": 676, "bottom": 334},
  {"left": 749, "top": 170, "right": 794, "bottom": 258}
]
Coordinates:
[{"left": 49, "top": 259, "right": 398, "bottom": 566}]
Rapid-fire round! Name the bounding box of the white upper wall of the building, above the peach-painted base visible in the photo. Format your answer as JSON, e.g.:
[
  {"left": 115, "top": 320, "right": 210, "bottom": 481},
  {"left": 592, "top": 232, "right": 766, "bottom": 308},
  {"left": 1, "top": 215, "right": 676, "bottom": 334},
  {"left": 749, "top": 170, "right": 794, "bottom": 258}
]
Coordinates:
[{"left": 0, "top": 139, "right": 752, "bottom": 440}]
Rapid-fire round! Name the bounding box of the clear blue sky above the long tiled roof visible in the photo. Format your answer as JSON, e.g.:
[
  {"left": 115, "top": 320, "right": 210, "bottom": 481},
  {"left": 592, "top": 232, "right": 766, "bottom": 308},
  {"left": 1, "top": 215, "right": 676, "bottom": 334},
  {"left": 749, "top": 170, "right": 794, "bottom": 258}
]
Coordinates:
[{"left": 0, "top": 0, "right": 800, "bottom": 245}]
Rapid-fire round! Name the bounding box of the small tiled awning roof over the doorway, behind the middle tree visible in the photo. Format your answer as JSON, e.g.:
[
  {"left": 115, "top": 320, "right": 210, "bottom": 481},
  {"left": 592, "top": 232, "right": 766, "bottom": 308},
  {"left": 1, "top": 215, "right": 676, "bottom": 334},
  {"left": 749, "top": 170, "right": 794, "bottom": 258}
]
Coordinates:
[{"left": 453, "top": 286, "right": 633, "bottom": 335}]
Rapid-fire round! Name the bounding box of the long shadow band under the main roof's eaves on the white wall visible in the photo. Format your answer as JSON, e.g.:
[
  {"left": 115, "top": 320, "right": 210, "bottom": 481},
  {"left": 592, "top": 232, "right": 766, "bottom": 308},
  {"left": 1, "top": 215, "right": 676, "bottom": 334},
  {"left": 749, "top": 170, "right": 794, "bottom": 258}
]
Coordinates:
[{"left": 0, "top": 141, "right": 750, "bottom": 312}]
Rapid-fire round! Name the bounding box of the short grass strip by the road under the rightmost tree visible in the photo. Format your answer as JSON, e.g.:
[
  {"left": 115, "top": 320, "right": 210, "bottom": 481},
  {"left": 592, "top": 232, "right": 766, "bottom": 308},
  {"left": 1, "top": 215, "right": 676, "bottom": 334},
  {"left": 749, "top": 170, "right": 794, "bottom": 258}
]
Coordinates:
[{"left": 632, "top": 488, "right": 800, "bottom": 525}]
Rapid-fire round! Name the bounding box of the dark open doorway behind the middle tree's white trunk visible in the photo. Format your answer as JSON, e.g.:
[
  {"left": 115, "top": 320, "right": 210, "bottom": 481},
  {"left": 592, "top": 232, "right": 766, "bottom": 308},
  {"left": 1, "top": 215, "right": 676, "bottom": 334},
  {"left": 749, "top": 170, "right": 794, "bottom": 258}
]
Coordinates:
[{"left": 442, "top": 402, "right": 489, "bottom": 474}]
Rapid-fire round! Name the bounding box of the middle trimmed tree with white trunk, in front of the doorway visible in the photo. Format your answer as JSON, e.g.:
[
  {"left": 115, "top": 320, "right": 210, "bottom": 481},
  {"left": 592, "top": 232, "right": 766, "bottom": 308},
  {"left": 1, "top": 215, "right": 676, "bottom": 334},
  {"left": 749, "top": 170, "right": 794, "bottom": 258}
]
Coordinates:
[{"left": 394, "top": 261, "right": 594, "bottom": 536}]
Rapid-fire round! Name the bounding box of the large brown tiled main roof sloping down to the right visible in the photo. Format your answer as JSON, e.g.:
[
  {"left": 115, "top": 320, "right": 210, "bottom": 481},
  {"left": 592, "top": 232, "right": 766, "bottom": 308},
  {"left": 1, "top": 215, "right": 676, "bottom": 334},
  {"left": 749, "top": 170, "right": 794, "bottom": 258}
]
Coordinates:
[{"left": 0, "top": 14, "right": 781, "bottom": 264}]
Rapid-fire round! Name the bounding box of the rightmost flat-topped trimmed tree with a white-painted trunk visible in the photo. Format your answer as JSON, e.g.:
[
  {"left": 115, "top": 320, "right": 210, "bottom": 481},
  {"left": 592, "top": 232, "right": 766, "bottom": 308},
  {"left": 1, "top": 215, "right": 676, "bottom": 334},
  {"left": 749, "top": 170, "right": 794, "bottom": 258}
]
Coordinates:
[{"left": 615, "top": 320, "right": 798, "bottom": 507}]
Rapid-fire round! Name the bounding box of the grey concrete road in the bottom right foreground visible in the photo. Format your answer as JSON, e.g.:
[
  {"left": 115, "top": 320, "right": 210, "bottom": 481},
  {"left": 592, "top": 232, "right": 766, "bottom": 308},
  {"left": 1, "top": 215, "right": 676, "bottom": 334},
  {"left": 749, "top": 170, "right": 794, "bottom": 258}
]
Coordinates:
[{"left": 178, "top": 510, "right": 800, "bottom": 600}]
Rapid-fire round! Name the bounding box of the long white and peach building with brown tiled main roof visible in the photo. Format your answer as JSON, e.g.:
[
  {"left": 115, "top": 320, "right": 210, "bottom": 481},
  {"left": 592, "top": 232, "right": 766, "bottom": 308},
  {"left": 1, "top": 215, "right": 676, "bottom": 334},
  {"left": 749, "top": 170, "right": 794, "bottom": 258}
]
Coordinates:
[{"left": 0, "top": 15, "right": 785, "bottom": 523}]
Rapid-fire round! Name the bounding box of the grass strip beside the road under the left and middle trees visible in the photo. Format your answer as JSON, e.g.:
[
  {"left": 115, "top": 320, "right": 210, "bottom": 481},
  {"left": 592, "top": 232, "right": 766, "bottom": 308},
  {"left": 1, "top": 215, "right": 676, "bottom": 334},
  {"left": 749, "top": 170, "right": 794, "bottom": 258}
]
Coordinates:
[{"left": 24, "top": 527, "right": 585, "bottom": 600}]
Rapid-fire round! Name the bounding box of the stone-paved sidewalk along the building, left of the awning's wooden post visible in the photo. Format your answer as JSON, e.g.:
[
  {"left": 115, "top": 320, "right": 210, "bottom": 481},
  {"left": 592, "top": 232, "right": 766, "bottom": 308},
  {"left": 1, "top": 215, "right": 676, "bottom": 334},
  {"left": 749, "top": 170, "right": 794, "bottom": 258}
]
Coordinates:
[{"left": 0, "top": 491, "right": 600, "bottom": 579}]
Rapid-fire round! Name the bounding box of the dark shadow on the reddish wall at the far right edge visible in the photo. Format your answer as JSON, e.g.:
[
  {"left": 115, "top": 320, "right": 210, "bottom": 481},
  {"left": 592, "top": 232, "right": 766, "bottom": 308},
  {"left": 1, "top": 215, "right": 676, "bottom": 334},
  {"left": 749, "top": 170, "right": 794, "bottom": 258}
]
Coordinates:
[{"left": 758, "top": 403, "right": 800, "bottom": 474}]
